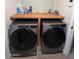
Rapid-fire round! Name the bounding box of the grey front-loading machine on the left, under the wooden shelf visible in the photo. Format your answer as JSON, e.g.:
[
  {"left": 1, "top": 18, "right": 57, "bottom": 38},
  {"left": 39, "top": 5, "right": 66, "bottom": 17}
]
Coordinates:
[{"left": 9, "top": 21, "right": 37, "bottom": 57}]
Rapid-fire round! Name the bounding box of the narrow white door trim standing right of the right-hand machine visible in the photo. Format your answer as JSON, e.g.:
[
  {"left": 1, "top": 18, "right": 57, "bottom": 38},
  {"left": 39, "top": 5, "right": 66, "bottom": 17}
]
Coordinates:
[{"left": 63, "top": 15, "right": 74, "bottom": 56}]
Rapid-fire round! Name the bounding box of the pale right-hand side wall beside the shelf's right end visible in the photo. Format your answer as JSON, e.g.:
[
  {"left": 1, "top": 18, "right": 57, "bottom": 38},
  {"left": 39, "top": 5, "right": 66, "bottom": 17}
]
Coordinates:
[{"left": 56, "top": 0, "right": 73, "bottom": 25}]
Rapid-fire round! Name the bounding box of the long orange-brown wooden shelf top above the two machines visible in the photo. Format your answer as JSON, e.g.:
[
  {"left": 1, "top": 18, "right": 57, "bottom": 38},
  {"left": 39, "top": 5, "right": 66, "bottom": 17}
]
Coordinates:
[{"left": 10, "top": 13, "right": 64, "bottom": 21}]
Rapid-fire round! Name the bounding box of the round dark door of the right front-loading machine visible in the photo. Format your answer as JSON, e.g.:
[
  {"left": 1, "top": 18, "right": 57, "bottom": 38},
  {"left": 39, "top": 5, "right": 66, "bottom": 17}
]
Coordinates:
[{"left": 43, "top": 27, "right": 66, "bottom": 48}]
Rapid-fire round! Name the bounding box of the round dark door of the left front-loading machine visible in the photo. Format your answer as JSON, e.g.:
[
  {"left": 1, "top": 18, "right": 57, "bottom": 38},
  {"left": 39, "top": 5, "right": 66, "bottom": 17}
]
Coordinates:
[{"left": 10, "top": 28, "right": 37, "bottom": 51}]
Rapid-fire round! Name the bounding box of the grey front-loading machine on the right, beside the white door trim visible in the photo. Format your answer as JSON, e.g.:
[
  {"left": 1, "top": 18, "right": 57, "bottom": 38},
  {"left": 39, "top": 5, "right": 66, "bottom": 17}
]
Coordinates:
[{"left": 41, "top": 19, "right": 66, "bottom": 54}]
